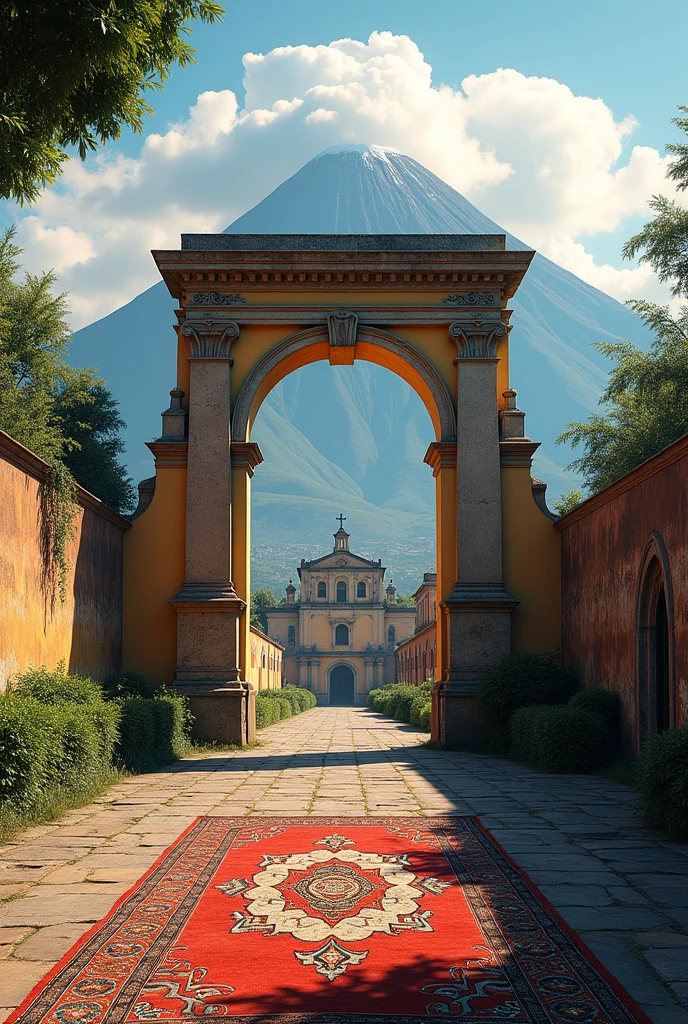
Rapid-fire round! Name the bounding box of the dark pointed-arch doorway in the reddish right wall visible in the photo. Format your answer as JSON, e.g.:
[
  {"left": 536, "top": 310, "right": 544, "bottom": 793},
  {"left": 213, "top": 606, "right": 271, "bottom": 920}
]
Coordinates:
[{"left": 636, "top": 530, "right": 676, "bottom": 748}]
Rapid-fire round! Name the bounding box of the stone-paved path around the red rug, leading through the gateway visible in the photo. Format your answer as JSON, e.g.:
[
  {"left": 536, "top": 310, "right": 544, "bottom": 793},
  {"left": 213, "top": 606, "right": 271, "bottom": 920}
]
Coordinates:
[{"left": 0, "top": 708, "right": 688, "bottom": 1024}]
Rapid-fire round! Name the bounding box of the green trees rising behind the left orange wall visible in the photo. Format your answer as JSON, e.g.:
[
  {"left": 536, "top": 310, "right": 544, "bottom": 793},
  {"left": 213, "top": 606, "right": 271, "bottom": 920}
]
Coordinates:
[{"left": 0, "top": 228, "right": 133, "bottom": 511}]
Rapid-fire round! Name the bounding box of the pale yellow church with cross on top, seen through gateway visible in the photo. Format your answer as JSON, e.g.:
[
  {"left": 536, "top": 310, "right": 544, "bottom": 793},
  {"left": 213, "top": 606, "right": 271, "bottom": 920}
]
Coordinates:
[{"left": 267, "top": 516, "right": 416, "bottom": 705}]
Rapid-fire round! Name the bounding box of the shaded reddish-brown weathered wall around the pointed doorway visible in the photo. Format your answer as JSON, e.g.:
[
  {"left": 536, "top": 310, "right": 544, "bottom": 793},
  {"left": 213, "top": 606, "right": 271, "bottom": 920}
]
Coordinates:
[{"left": 557, "top": 435, "right": 688, "bottom": 751}]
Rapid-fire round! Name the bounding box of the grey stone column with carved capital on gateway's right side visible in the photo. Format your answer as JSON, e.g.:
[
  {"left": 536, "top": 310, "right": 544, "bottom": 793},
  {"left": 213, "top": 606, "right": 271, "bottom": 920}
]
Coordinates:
[{"left": 437, "top": 314, "right": 518, "bottom": 746}]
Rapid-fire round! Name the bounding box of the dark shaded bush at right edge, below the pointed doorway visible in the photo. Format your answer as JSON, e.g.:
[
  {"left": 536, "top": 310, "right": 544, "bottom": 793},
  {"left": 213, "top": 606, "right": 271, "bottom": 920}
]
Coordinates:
[{"left": 638, "top": 726, "right": 688, "bottom": 840}]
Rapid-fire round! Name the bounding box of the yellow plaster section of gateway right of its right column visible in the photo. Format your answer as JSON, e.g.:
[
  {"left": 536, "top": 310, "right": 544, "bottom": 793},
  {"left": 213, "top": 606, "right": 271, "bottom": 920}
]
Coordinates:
[{"left": 502, "top": 467, "right": 561, "bottom": 652}]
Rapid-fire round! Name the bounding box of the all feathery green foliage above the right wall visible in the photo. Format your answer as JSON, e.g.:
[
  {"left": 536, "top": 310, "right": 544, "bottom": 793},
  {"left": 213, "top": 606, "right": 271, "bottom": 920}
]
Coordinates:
[{"left": 557, "top": 106, "right": 688, "bottom": 493}]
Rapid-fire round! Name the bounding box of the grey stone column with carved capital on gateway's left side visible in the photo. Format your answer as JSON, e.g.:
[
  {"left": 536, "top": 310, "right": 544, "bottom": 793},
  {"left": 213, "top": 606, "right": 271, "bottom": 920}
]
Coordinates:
[{"left": 172, "top": 316, "right": 255, "bottom": 744}]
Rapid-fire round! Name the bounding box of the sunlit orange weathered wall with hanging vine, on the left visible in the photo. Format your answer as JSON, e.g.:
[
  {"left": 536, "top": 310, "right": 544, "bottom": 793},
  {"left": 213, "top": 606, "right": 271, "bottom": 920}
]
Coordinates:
[{"left": 0, "top": 431, "right": 129, "bottom": 689}]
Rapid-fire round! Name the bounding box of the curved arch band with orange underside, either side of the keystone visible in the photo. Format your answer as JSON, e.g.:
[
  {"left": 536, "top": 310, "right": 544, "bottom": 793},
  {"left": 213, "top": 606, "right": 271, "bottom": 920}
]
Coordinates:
[{"left": 231, "top": 327, "right": 457, "bottom": 441}]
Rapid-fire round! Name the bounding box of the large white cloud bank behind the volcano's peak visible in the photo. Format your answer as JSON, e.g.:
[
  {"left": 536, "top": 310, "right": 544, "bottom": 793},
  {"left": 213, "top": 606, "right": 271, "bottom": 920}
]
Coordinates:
[{"left": 5, "top": 32, "right": 679, "bottom": 327}]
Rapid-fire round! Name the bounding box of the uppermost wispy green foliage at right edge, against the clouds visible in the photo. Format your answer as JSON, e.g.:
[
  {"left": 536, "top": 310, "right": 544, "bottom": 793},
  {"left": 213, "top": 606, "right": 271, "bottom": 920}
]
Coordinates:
[{"left": 622, "top": 106, "right": 688, "bottom": 297}]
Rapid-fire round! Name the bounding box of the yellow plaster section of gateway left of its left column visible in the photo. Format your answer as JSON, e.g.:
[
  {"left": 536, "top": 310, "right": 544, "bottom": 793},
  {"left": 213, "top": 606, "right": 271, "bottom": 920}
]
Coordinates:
[{"left": 122, "top": 467, "right": 186, "bottom": 685}]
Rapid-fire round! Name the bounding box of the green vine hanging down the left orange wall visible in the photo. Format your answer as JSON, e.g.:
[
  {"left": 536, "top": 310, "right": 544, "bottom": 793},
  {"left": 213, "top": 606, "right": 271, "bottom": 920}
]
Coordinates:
[{"left": 40, "top": 460, "right": 79, "bottom": 612}]
